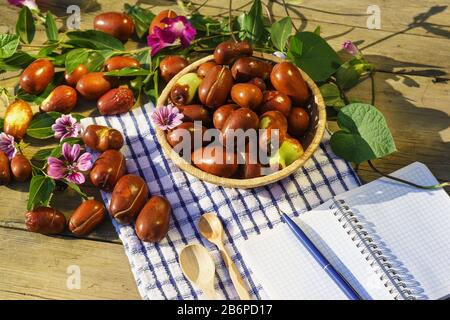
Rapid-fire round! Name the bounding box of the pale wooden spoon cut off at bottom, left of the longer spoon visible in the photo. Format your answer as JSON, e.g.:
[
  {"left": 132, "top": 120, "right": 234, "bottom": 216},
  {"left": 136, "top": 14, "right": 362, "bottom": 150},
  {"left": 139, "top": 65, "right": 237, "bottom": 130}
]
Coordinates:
[{"left": 179, "top": 244, "right": 218, "bottom": 300}]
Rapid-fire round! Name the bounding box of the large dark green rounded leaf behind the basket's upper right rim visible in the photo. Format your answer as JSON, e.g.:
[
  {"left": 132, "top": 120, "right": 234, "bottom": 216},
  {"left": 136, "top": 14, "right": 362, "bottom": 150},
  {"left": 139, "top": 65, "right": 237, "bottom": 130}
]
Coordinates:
[{"left": 288, "top": 32, "right": 341, "bottom": 82}]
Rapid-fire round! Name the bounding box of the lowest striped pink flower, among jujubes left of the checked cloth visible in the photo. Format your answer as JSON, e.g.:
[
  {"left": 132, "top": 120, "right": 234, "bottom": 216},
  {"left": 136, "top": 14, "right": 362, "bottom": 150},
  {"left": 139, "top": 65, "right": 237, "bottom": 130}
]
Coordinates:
[{"left": 47, "top": 142, "right": 92, "bottom": 184}]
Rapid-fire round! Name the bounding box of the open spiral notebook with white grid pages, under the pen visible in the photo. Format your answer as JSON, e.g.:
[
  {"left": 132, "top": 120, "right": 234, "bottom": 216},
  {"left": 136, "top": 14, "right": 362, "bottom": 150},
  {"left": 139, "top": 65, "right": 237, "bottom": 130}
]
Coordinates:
[{"left": 240, "top": 162, "right": 450, "bottom": 299}]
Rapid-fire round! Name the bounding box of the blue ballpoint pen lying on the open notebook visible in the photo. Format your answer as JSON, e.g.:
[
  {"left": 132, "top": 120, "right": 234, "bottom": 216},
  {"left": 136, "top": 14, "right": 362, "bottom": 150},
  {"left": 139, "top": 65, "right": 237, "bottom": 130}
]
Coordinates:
[{"left": 279, "top": 212, "right": 361, "bottom": 300}]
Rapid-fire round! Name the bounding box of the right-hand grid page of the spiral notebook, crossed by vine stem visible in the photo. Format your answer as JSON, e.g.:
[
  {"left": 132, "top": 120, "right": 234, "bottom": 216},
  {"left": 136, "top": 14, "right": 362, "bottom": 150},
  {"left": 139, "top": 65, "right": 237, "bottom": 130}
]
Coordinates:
[{"left": 336, "top": 162, "right": 450, "bottom": 299}]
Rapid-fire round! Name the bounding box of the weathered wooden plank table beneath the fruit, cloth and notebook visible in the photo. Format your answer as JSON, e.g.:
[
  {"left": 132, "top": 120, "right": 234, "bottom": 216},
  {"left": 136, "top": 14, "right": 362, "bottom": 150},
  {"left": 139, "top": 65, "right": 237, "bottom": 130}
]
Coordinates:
[{"left": 0, "top": 0, "right": 450, "bottom": 299}]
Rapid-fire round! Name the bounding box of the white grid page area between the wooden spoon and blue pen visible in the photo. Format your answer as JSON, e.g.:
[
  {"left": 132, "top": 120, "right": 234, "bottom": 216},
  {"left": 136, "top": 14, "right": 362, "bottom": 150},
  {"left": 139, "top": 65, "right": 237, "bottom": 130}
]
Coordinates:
[{"left": 240, "top": 223, "right": 347, "bottom": 300}]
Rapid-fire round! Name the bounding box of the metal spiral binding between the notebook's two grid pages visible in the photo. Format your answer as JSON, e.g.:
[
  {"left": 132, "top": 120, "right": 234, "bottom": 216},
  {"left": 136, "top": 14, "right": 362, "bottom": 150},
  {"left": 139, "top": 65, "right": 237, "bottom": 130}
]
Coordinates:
[{"left": 330, "top": 199, "right": 419, "bottom": 300}]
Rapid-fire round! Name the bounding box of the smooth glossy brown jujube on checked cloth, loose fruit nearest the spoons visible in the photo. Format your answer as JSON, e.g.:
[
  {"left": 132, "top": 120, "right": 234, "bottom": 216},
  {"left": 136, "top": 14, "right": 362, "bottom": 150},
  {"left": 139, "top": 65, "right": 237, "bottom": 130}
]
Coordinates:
[{"left": 136, "top": 196, "right": 172, "bottom": 242}]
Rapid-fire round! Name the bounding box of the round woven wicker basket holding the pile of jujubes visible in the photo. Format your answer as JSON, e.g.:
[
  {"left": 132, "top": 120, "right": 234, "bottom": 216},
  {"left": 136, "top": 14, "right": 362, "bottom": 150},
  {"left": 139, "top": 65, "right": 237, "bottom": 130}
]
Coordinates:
[{"left": 156, "top": 52, "right": 326, "bottom": 189}]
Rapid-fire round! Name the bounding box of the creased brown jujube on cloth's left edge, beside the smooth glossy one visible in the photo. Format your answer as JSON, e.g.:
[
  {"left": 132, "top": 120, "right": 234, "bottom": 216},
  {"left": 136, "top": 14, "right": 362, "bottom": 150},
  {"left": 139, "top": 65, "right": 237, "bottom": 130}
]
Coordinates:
[{"left": 109, "top": 174, "right": 148, "bottom": 224}]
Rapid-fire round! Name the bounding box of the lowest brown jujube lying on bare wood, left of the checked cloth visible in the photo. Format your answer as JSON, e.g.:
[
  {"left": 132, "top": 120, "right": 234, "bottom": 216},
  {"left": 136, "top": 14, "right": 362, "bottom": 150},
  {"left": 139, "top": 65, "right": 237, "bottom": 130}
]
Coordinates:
[{"left": 69, "top": 199, "right": 105, "bottom": 236}]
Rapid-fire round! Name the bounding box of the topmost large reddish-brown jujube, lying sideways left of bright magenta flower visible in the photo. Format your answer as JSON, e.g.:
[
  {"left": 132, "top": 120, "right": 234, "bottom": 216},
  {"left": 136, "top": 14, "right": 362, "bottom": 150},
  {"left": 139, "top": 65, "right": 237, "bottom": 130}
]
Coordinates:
[{"left": 94, "top": 12, "right": 134, "bottom": 42}]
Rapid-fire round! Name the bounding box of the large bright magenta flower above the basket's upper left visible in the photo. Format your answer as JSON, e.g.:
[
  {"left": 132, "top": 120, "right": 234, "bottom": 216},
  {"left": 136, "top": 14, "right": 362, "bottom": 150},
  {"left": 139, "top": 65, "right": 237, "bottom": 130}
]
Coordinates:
[{"left": 147, "top": 16, "right": 197, "bottom": 56}]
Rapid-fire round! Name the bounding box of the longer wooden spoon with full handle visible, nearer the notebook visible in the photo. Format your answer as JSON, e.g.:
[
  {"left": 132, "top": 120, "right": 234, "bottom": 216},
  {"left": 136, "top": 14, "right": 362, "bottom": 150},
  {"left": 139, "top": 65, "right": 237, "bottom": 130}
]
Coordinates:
[{"left": 198, "top": 213, "right": 251, "bottom": 300}]
